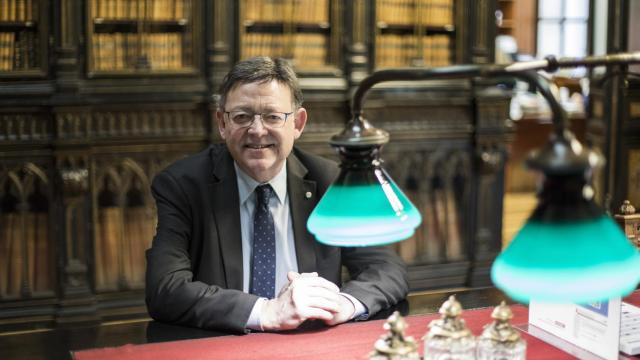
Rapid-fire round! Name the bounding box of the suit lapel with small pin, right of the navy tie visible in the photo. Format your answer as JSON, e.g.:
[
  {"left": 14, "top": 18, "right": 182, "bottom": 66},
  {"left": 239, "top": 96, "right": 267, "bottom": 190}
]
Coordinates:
[{"left": 287, "top": 154, "right": 319, "bottom": 273}]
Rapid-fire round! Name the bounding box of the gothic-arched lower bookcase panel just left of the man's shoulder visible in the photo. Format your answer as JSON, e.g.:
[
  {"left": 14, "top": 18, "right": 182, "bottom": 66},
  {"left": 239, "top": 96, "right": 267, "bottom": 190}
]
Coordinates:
[{"left": 92, "top": 154, "right": 176, "bottom": 292}]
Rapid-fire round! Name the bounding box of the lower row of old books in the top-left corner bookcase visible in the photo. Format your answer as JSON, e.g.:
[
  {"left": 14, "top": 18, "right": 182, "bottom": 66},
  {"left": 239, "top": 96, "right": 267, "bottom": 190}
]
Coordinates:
[{"left": 0, "top": 31, "right": 38, "bottom": 71}]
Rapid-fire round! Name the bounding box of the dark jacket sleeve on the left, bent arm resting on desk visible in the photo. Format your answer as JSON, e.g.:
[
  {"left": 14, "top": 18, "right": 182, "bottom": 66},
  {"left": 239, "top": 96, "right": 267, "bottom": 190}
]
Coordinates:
[{"left": 145, "top": 170, "right": 258, "bottom": 332}]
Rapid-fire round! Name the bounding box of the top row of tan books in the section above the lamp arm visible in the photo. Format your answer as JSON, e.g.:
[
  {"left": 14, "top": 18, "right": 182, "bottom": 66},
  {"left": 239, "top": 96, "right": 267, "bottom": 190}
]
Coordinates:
[{"left": 376, "top": 0, "right": 454, "bottom": 26}]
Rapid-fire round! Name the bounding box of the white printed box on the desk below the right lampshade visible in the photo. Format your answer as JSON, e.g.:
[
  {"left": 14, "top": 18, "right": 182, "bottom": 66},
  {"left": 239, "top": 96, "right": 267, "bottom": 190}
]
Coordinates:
[{"left": 529, "top": 297, "right": 622, "bottom": 360}]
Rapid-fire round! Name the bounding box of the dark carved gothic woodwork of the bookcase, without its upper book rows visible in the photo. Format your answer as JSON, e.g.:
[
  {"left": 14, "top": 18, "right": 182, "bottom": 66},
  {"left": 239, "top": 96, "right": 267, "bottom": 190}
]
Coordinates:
[{"left": 0, "top": 0, "right": 506, "bottom": 330}]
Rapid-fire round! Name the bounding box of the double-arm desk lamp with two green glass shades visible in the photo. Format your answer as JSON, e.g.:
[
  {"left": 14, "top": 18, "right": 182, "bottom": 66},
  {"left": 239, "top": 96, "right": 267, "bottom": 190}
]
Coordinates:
[{"left": 307, "top": 52, "right": 640, "bottom": 303}]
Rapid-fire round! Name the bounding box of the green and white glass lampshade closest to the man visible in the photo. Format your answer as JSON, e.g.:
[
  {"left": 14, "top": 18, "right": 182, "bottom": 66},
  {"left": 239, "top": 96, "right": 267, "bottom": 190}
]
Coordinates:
[{"left": 307, "top": 167, "right": 422, "bottom": 246}]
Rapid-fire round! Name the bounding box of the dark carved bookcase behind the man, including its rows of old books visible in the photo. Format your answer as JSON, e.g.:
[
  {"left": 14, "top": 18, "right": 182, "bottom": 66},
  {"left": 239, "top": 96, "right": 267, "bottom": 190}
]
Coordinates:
[{"left": 0, "top": 0, "right": 508, "bottom": 331}]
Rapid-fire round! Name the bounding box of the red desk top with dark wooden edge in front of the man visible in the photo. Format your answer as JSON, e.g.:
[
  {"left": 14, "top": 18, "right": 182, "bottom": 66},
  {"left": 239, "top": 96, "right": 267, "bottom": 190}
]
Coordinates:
[{"left": 0, "top": 288, "right": 640, "bottom": 360}]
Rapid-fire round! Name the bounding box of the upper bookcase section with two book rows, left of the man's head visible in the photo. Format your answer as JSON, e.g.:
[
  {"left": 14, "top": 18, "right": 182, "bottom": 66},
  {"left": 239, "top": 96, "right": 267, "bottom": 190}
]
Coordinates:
[{"left": 87, "top": 0, "right": 199, "bottom": 76}]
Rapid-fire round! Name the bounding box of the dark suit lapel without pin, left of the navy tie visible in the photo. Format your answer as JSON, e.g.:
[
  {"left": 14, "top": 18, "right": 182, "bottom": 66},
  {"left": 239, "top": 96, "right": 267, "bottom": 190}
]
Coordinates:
[{"left": 209, "top": 149, "right": 243, "bottom": 291}]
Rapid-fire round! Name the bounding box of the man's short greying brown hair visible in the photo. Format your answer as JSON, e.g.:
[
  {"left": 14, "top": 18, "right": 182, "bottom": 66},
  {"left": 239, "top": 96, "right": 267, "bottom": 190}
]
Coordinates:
[{"left": 218, "top": 56, "right": 302, "bottom": 109}]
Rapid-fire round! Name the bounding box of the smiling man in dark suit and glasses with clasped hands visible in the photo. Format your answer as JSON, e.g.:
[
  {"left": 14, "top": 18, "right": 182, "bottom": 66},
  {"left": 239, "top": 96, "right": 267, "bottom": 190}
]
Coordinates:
[{"left": 146, "top": 57, "right": 408, "bottom": 332}]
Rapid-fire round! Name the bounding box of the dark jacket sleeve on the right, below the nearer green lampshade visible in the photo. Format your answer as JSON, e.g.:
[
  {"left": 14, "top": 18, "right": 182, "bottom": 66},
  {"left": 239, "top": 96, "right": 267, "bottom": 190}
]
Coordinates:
[{"left": 341, "top": 247, "right": 409, "bottom": 316}]
